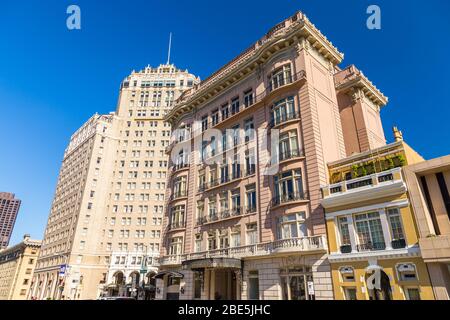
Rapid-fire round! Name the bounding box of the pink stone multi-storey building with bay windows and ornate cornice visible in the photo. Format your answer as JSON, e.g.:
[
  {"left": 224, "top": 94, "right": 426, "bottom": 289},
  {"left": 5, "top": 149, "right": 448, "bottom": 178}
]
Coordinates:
[{"left": 156, "top": 12, "right": 387, "bottom": 300}]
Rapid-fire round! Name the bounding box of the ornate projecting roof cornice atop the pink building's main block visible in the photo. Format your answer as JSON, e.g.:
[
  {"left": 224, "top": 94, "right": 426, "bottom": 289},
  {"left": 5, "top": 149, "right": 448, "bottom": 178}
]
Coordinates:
[{"left": 165, "top": 11, "right": 344, "bottom": 124}]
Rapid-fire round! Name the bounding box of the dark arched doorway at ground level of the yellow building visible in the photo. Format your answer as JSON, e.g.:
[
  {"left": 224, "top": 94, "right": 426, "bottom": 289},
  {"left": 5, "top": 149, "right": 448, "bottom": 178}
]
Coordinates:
[{"left": 366, "top": 266, "right": 392, "bottom": 300}]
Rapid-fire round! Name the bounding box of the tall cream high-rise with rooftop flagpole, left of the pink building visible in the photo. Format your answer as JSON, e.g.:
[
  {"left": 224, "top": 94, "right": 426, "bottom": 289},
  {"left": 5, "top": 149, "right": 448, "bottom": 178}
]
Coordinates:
[{"left": 29, "top": 64, "right": 199, "bottom": 300}]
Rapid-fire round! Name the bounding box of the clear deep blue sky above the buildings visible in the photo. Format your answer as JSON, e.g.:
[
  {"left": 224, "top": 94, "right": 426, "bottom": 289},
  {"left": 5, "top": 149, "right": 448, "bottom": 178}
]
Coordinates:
[{"left": 0, "top": 0, "right": 450, "bottom": 243}]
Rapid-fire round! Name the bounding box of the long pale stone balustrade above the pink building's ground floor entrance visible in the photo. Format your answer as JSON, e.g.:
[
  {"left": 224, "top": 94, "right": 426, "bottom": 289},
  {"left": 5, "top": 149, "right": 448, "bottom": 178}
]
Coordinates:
[{"left": 159, "top": 236, "right": 327, "bottom": 265}]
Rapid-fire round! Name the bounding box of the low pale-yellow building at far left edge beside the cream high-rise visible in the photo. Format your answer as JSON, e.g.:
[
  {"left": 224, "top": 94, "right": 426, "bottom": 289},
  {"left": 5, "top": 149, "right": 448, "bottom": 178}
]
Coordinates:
[{"left": 0, "top": 235, "right": 41, "bottom": 300}]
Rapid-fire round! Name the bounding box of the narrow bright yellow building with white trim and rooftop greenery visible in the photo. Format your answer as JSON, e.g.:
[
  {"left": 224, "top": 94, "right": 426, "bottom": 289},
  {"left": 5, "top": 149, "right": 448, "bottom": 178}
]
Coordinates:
[{"left": 322, "top": 137, "right": 434, "bottom": 300}]
